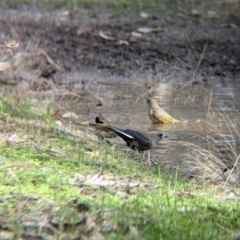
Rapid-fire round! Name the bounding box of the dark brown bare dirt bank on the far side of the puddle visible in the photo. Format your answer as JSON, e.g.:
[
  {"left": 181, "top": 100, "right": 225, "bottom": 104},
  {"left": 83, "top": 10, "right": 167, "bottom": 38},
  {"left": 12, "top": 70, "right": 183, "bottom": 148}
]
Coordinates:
[{"left": 0, "top": 3, "right": 240, "bottom": 83}]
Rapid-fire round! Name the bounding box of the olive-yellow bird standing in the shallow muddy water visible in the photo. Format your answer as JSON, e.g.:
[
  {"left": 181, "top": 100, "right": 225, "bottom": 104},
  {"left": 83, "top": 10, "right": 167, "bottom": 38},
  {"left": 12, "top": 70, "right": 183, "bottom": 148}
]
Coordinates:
[{"left": 147, "top": 97, "right": 181, "bottom": 124}]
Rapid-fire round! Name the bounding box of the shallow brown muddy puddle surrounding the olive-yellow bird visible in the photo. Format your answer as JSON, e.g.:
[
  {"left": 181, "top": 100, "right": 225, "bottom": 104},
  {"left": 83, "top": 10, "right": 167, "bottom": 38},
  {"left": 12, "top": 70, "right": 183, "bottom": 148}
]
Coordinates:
[{"left": 61, "top": 71, "right": 240, "bottom": 182}]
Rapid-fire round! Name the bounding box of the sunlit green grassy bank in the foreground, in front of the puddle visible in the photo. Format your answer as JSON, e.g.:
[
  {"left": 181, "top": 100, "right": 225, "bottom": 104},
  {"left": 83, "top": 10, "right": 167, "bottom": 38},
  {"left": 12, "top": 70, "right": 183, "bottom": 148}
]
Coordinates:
[{"left": 0, "top": 96, "right": 240, "bottom": 239}]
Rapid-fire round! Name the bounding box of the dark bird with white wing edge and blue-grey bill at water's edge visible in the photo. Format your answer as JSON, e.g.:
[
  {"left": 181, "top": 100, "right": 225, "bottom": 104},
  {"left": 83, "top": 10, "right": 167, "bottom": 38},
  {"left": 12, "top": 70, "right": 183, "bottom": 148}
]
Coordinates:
[{"left": 89, "top": 123, "right": 167, "bottom": 166}]
